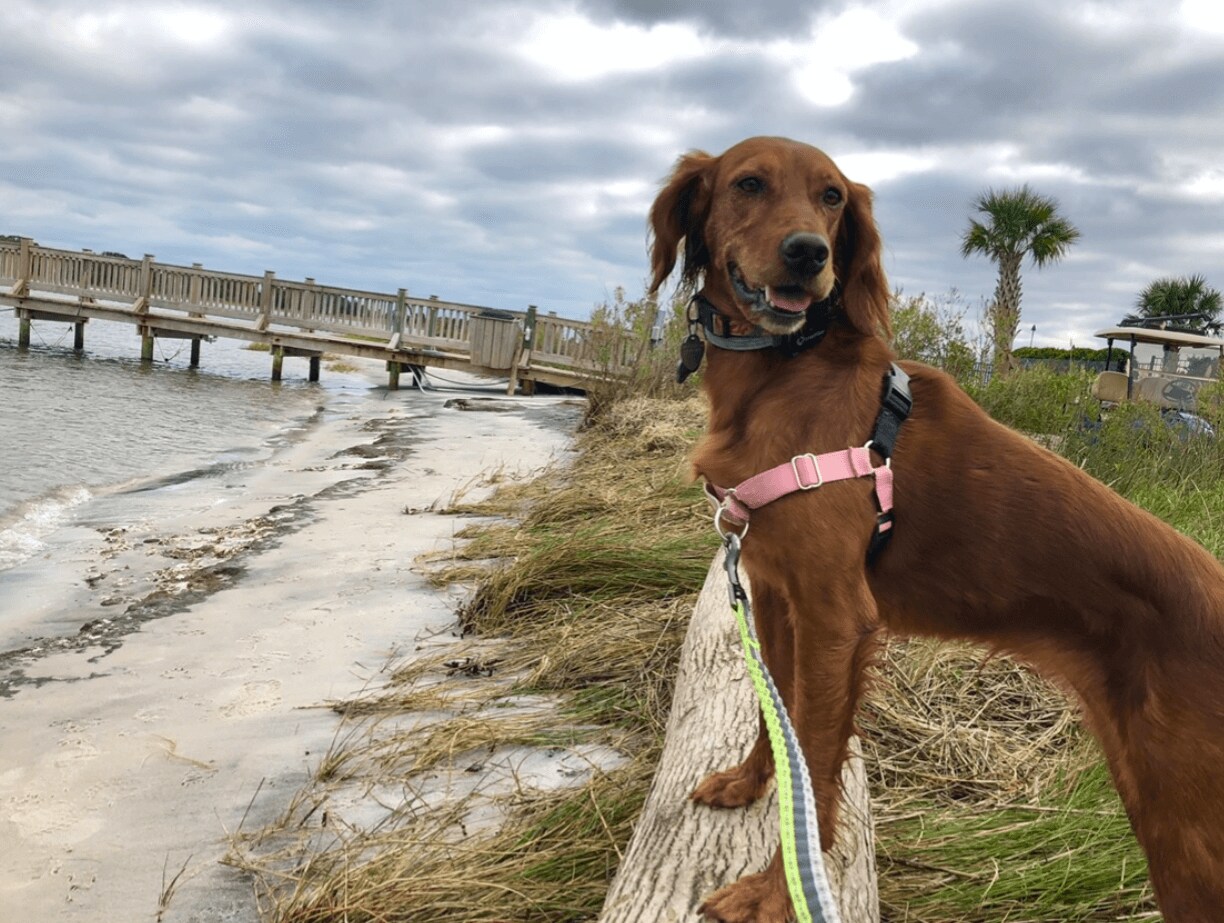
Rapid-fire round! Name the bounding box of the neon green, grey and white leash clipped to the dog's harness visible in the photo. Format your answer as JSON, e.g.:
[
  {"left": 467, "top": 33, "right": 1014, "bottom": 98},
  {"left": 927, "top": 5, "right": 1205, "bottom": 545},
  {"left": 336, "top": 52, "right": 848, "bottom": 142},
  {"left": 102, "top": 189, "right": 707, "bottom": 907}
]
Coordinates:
[{"left": 720, "top": 530, "right": 841, "bottom": 923}]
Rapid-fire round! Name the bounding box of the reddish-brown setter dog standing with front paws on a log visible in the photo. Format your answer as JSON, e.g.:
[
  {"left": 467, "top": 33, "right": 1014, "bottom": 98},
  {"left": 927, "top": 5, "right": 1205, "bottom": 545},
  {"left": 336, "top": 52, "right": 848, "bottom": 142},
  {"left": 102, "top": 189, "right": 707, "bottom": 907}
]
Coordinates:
[{"left": 650, "top": 137, "right": 1224, "bottom": 923}]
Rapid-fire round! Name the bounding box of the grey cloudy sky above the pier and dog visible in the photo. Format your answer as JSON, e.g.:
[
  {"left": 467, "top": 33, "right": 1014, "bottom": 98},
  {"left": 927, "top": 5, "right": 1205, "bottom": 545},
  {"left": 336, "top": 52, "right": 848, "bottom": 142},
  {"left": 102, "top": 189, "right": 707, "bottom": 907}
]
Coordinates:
[{"left": 0, "top": 0, "right": 1224, "bottom": 345}]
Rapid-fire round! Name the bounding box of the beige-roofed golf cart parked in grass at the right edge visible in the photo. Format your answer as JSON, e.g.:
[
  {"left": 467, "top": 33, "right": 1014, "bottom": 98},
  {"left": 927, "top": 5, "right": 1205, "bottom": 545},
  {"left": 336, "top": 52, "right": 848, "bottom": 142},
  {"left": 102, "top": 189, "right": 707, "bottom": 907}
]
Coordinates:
[{"left": 1092, "top": 318, "right": 1224, "bottom": 436}]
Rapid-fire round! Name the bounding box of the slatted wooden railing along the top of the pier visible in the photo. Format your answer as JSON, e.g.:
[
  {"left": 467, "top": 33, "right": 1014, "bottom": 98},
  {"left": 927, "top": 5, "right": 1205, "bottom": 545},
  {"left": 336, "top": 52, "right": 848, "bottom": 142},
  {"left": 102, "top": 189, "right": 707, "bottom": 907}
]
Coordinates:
[{"left": 0, "top": 237, "right": 636, "bottom": 379}]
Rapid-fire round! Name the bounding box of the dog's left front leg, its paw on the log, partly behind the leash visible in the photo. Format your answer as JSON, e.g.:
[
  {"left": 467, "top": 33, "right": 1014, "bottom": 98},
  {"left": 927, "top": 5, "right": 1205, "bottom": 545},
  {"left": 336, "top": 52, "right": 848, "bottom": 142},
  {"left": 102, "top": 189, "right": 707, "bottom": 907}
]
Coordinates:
[{"left": 690, "top": 584, "right": 794, "bottom": 808}]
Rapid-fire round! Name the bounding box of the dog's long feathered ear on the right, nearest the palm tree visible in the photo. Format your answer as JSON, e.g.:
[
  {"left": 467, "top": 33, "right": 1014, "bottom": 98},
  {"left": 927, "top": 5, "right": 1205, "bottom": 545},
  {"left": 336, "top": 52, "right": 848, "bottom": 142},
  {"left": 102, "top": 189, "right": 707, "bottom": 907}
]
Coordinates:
[{"left": 837, "top": 182, "right": 892, "bottom": 338}]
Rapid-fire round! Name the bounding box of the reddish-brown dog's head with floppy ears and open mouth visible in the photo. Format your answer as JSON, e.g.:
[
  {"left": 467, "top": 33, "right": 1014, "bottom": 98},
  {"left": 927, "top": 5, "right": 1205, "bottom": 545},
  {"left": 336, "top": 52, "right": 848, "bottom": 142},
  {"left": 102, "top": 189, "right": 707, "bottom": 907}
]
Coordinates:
[{"left": 650, "top": 138, "right": 889, "bottom": 335}]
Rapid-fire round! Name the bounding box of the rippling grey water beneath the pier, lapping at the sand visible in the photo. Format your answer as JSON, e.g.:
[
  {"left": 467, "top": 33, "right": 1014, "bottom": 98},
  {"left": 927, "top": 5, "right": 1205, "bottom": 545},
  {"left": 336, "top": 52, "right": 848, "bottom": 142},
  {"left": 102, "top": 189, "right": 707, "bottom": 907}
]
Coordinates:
[{"left": 0, "top": 308, "right": 371, "bottom": 572}]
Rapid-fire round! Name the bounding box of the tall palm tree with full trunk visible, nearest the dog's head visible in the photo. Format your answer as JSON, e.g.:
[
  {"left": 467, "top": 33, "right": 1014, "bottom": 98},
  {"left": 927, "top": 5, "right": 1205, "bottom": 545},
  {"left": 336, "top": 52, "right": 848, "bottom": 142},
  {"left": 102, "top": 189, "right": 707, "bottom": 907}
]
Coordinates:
[{"left": 961, "top": 185, "right": 1080, "bottom": 372}]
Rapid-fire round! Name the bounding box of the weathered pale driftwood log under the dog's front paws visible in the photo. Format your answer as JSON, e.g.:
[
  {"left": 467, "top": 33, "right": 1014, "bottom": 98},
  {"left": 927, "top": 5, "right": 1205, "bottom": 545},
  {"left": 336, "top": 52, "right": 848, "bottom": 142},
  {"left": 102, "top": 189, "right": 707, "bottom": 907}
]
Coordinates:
[{"left": 600, "top": 552, "right": 880, "bottom": 923}]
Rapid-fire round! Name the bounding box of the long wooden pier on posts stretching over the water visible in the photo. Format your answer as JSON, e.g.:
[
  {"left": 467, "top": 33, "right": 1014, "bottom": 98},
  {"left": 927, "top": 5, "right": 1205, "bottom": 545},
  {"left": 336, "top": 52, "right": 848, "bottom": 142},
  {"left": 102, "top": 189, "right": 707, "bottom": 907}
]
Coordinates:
[{"left": 0, "top": 237, "right": 636, "bottom": 393}]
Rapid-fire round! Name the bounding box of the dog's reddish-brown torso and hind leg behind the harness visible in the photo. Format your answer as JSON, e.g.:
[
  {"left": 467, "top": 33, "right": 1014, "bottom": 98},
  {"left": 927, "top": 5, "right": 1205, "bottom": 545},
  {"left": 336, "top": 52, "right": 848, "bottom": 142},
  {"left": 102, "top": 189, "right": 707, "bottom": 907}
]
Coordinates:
[{"left": 869, "top": 364, "right": 1224, "bottom": 921}]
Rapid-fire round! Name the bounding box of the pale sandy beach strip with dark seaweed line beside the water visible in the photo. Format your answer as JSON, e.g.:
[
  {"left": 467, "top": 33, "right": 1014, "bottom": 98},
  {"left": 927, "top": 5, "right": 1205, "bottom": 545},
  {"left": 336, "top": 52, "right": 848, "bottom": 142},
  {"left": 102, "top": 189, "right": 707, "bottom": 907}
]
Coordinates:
[{"left": 0, "top": 372, "right": 580, "bottom": 923}]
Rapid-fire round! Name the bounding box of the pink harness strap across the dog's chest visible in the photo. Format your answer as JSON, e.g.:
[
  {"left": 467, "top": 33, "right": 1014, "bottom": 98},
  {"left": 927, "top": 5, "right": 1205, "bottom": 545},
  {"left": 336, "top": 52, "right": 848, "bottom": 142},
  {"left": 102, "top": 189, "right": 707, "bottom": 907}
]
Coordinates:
[{"left": 705, "top": 443, "right": 892, "bottom": 533}]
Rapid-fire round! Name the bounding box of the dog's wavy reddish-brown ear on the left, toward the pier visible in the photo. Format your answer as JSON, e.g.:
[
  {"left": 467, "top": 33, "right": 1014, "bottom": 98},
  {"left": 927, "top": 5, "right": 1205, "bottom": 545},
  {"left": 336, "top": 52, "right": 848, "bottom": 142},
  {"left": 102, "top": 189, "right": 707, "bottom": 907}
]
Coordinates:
[{"left": 650, "top": 151, "right": 717, "bottom": 294}]
